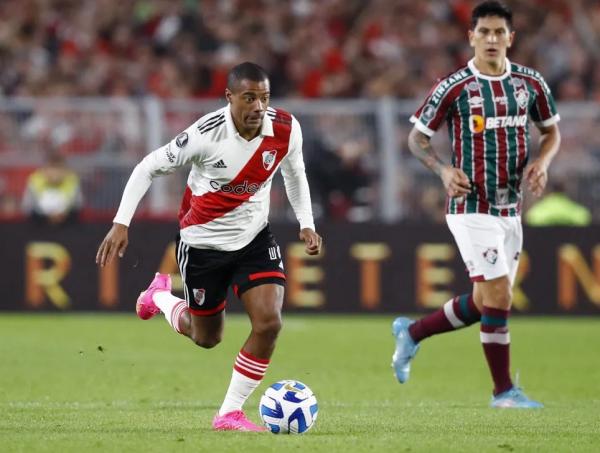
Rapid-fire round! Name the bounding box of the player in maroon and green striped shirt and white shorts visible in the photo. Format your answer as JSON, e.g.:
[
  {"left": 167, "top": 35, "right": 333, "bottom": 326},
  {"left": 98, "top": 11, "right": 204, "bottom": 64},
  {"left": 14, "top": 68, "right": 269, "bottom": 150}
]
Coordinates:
[{"left": 392, "top": 1, "right": 560, "bottom": 408}]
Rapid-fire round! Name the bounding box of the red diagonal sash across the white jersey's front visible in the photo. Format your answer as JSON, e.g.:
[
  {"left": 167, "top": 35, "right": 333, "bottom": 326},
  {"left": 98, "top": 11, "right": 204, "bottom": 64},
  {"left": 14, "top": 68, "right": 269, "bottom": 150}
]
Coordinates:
[{"left": 179, "top": 110, "right": 292, "bottom": 229}]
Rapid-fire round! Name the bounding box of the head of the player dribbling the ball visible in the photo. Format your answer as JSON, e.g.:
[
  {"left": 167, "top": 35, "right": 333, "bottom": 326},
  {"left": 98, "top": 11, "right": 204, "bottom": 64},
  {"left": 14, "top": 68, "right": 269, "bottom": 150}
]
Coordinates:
[{"left": 225, "top": 62, "right": 270, "bottom": 134}]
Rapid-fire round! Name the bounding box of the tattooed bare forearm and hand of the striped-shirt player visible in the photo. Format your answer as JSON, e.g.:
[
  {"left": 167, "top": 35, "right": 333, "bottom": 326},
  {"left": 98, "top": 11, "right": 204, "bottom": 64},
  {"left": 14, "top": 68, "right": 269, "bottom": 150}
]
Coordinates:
[{"left": 408, "top": 127, "right": 471, "bottom": 197}]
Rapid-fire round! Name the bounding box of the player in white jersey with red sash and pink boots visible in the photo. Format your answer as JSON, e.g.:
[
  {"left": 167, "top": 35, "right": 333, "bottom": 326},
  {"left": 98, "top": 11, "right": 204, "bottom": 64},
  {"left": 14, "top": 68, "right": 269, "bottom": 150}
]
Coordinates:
[{"left": 96, "top": 62, "right": 321, "bottom": 431}]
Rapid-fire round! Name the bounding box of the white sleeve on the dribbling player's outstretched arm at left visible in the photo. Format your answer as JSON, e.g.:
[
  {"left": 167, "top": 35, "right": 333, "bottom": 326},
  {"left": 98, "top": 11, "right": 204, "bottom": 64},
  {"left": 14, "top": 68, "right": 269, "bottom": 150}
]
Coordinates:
[{"left": 113, "top": 123, "right": 204, "bottom": 226}]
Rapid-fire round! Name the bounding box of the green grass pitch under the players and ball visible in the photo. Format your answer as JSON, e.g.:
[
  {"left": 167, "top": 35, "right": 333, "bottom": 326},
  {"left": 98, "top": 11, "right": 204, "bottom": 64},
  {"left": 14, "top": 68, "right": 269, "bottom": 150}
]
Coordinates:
[{"left": 0, "top": 314, "right": 600, "bottom": 453}]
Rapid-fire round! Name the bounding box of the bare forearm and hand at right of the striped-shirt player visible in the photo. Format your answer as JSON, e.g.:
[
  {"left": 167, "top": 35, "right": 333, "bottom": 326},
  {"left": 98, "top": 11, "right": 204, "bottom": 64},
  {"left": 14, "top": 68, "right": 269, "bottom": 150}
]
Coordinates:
[{"left": 525, "top": 123, "right": 561, "bottom": 197}]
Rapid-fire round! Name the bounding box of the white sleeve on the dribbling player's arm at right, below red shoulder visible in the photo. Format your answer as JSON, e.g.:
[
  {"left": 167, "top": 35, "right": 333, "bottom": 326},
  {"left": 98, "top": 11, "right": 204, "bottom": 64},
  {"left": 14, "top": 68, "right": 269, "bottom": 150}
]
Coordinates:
[{"left": 281, "top": 116, "right": 315, "bottom": 230}]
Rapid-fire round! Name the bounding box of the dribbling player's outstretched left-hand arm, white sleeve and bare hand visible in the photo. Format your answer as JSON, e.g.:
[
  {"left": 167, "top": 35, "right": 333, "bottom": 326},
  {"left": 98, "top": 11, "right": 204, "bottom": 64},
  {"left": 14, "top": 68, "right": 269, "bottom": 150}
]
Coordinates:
[{"left": 96, "top": 125, "right": 200, "bottom": 266}]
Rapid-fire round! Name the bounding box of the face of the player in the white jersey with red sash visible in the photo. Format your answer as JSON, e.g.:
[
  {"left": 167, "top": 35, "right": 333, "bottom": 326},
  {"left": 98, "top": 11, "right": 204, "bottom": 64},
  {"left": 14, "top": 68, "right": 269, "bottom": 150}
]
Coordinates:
[{"left": 225, "top": 79, "right": 270, "bottom": 138}]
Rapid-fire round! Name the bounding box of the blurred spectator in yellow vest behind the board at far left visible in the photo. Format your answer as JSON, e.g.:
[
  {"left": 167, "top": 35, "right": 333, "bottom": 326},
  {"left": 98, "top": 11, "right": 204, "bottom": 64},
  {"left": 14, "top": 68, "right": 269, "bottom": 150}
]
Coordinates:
[{"left": 22, "top": 153, "right": 83, "bottom": 225}]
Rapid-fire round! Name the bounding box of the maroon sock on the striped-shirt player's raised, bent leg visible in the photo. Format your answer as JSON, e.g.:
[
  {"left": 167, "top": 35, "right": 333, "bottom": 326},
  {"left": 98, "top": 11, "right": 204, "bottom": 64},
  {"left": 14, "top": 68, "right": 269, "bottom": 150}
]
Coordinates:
[{"left": 408, "top": 294, "right": 481, "bottom": 343}]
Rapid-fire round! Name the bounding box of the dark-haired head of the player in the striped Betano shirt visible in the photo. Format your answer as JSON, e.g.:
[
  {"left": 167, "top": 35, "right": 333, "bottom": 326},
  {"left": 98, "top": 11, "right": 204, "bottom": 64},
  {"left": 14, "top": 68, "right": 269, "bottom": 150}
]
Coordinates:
[{"left": 469, "top": 0, "right": 515, "bottom": 64}]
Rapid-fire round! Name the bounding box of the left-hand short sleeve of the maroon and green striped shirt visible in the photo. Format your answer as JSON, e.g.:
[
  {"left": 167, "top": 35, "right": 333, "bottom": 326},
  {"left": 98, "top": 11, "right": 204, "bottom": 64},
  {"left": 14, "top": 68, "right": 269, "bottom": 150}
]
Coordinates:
[{"left": 410, "top": 79, "right": 454, "bottom": 137}]
